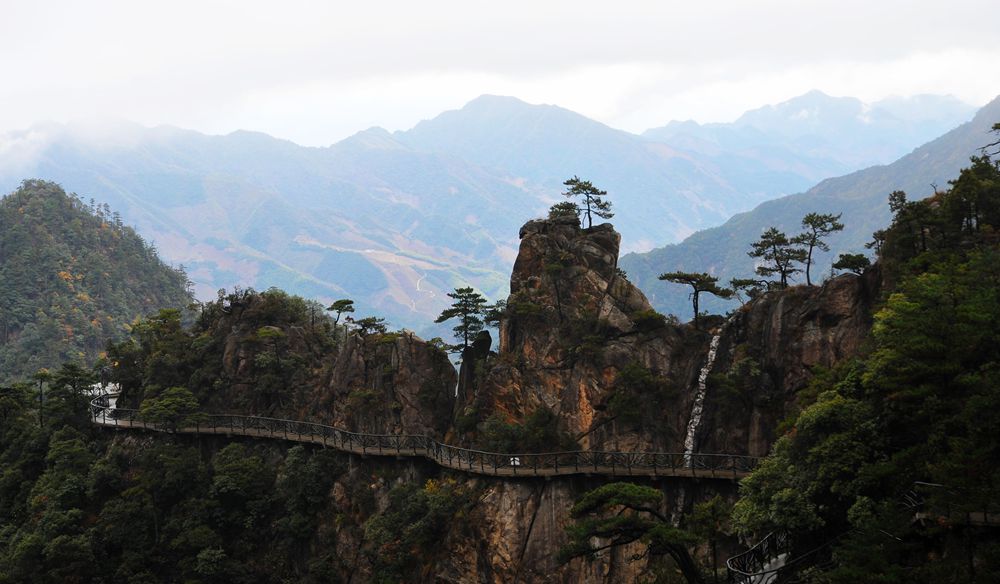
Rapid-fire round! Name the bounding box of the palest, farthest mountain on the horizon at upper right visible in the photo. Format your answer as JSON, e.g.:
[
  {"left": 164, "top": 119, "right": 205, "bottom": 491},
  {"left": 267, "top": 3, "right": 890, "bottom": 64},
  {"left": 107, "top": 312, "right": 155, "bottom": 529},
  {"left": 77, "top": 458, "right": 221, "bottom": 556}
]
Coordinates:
[{"left": 643, "top": 91, "right": 975, "bottom": 176}]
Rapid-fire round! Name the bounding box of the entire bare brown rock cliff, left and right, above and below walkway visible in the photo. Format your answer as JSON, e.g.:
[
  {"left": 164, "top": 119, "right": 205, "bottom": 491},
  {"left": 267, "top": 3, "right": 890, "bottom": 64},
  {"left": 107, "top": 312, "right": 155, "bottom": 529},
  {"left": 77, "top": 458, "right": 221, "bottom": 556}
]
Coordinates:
[{"left": 117, "top": 221, "right": 880, "bottom": 583}]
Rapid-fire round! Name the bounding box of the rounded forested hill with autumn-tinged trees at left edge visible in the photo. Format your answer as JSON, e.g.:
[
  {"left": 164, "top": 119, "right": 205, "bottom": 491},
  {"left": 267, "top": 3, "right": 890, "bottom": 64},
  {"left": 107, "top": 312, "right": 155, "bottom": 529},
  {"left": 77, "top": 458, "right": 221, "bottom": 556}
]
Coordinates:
[{"left": 0, "top": 181, "right": 192, "bottom": 382}]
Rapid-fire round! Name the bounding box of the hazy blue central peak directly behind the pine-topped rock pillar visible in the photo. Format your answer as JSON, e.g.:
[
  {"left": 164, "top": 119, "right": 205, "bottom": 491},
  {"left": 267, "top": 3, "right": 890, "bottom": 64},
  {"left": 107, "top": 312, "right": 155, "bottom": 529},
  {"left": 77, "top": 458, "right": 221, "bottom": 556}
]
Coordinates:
[{"left": 394, "top": 95, "right": 829, "bottom": 250}]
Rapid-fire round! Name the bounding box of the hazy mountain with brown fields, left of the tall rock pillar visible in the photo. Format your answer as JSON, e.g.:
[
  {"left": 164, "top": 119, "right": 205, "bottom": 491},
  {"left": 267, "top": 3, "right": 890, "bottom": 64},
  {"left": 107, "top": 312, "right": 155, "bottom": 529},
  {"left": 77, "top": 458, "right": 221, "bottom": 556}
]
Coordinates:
[{"left": 0, "top": 125, "right": 546, "bottom": 334}]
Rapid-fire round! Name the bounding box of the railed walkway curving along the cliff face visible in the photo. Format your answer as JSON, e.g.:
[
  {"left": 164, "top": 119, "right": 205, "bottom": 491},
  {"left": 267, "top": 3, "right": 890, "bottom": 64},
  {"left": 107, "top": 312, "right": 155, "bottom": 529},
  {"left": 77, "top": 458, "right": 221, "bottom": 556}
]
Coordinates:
[{"left": 90, "top": 393, "right": 759, "bottom": 480}]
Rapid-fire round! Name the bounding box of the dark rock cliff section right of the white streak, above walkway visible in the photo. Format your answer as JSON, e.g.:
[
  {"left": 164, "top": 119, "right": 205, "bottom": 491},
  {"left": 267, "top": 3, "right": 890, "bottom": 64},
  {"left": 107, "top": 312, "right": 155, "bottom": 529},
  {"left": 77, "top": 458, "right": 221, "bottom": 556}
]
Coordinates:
[{"left": 697, "top": 264, "right": 882, "bottom": 456}]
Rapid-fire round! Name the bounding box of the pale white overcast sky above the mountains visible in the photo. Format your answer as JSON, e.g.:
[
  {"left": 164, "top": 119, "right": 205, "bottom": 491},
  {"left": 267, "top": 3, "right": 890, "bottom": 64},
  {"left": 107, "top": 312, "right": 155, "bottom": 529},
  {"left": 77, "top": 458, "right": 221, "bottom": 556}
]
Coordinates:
[{"left": 0, "top": 0, "right": 1000, "bottom": 145}]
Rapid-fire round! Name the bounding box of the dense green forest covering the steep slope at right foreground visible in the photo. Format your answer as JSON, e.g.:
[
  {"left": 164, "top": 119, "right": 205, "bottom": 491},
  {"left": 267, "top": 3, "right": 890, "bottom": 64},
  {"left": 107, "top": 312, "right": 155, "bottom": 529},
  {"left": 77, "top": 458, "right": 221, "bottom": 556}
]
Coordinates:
[{"left": 734, "top": 157, "right": 1000, "bottom": 583}]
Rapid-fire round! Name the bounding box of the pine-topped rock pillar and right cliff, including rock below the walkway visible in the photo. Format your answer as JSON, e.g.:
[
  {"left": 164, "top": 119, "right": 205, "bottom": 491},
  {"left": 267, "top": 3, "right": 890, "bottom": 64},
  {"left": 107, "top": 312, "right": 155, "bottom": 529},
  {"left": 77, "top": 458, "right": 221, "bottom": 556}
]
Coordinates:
[{"left": 437, "top": 221, "right": 880, "bottom": 582}]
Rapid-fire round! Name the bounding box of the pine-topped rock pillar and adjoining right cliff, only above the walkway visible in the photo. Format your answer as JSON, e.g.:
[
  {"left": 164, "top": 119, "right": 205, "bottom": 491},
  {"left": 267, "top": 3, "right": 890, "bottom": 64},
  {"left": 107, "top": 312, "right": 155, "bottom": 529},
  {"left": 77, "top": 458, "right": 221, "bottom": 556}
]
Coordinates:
[{"left": 457, "top": 221, "right": 880, "bottom": 455}]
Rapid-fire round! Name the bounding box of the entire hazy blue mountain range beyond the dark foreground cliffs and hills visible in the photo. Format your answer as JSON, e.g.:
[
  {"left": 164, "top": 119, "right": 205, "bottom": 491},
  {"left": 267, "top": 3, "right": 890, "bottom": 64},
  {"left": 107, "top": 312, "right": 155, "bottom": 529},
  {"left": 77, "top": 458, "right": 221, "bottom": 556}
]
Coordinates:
[{"left": 0, "top": 93, "right": 969, "bottom": 330}]
